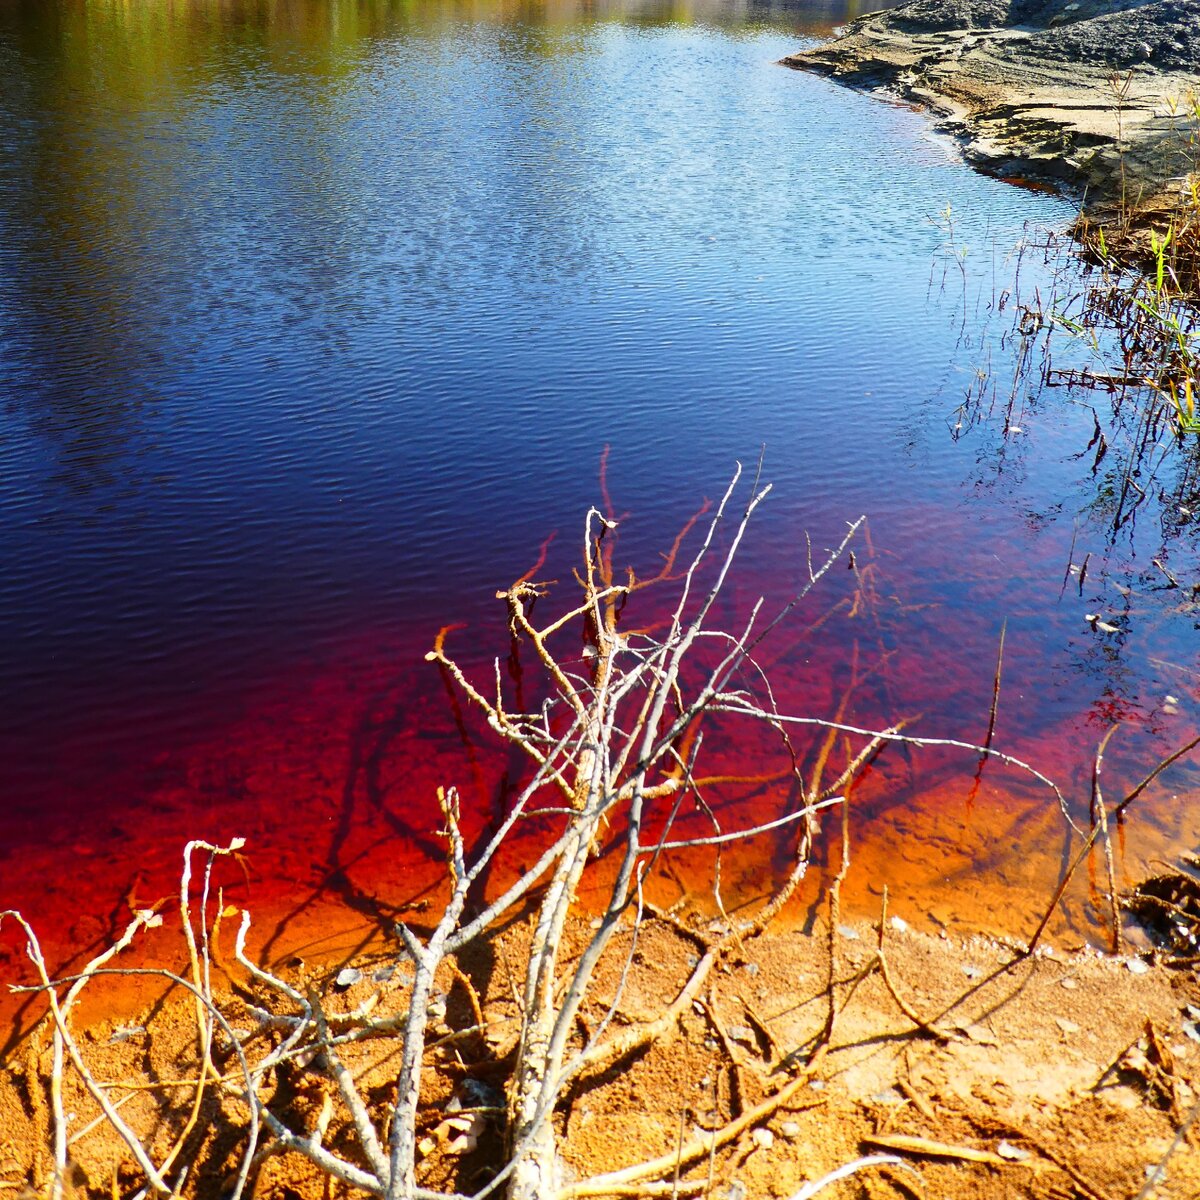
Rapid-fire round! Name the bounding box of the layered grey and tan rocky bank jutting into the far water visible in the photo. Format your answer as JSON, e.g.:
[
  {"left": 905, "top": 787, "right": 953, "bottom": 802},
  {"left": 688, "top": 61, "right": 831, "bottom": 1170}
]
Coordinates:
[{"left": 784, "top": 0, "right": 1200, "bottom": 206}]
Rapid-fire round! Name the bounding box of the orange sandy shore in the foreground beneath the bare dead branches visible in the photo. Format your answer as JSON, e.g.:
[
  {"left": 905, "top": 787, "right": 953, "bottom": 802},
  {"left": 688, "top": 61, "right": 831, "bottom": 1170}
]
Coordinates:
[{"left": 0, "top": 917, "right": 1200, "bottom": 1200}]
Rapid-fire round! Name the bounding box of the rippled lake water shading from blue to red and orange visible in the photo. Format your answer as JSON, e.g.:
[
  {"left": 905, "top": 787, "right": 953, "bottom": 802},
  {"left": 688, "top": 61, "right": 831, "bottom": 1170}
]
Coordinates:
[{"left": 0, "top": 0, "right": 1200, "bottom": 1003}]
